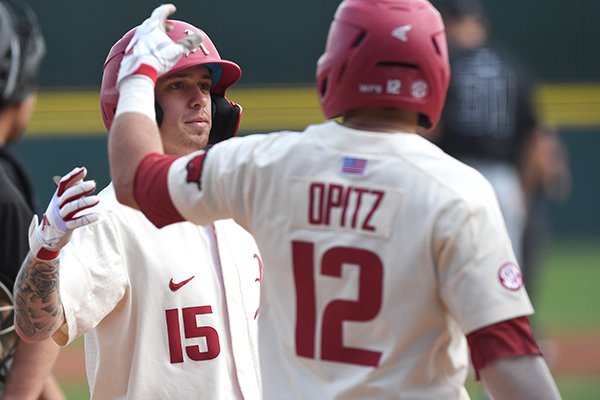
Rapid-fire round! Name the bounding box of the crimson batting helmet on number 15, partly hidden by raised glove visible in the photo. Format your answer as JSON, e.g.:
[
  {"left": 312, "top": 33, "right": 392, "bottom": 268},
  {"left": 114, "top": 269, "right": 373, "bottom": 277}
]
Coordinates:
[{"left": 100, "top": 20, "right": 242, "bottom": 144}]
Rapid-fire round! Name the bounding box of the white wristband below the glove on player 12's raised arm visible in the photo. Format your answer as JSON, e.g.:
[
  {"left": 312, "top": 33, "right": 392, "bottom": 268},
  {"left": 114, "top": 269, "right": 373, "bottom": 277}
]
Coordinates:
[{"left": 115, "top": 74, "right": 156, "bottom": 121}]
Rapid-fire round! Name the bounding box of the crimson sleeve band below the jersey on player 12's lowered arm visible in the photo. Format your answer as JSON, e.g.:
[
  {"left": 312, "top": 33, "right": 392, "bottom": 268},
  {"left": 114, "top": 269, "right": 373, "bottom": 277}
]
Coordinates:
[{"left": 467, "top": 317, "right": 542, "bottom": 380}]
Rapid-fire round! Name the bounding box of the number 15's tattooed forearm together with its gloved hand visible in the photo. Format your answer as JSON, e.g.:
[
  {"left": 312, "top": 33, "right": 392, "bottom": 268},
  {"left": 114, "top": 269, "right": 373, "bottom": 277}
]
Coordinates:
[{"left": 14, "top": 168, "right": 98, "bottom": 342}]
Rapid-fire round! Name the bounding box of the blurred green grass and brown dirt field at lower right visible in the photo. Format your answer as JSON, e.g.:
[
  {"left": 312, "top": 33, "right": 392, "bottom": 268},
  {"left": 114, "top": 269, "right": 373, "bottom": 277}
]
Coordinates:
[{"left": 469, "top": 237, "right": 600, "bottom": 400}]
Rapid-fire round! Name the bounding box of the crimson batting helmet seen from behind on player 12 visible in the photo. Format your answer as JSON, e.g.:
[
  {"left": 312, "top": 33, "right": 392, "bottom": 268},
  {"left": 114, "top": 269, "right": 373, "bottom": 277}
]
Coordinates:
[{"left": 317, "top": 0, "right": 450, "bottom": 128}]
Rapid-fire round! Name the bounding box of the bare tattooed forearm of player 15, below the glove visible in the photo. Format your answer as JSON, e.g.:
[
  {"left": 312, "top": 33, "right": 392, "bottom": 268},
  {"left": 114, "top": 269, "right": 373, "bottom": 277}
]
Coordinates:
[{"left": 15, "top": 254, "right": 64, "bottom": 336}]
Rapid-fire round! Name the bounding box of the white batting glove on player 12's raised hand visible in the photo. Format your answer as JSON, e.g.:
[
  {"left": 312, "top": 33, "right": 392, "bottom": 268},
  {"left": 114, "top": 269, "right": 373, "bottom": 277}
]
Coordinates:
[{"left": 117, "top": 4, "right": 202, "bottom": 87}]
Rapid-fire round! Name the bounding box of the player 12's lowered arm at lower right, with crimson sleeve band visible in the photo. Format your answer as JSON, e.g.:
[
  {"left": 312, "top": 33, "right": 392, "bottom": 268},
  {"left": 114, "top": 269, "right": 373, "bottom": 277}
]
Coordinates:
[{"left": 467, "top": 317, "right": 560, "bottom": 400}]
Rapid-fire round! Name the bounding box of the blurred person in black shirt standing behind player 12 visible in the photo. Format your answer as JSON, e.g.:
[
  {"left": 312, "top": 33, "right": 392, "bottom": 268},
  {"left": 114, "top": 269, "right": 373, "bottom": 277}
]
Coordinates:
[{"left": 429, "top": 0, "right": 570, "bottom": 303}]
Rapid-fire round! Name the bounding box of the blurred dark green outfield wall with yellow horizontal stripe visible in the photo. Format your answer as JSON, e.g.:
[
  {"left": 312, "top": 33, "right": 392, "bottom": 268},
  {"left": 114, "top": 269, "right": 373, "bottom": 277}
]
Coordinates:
[{"left": 15, "top": 0, "right": 600, "bottom": 238}]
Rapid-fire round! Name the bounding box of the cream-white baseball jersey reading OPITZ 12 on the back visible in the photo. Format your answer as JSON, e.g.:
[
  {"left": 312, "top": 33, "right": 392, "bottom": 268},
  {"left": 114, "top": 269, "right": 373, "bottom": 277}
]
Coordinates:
[{"left": 156, "top": 121, "right": 533, "bottom": 400}]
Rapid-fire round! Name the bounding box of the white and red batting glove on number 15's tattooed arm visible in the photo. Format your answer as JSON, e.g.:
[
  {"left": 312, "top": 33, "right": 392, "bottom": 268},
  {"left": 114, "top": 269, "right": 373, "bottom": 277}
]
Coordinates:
[{"left": 29, "top": 167, "right": 99, "bottom": 261}]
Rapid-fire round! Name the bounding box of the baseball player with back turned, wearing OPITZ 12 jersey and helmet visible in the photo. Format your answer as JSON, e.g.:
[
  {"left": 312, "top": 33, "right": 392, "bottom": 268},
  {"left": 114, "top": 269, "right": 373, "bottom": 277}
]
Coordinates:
[{"left": 109, "top": 0, "right": 560, "bottom": 400}]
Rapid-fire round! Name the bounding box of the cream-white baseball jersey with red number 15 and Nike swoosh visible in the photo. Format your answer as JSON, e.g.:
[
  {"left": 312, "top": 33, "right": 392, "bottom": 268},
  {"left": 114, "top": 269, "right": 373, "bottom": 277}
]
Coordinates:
[{"left": 54, "top": 185, "right": 262, "bottom": 399}]
